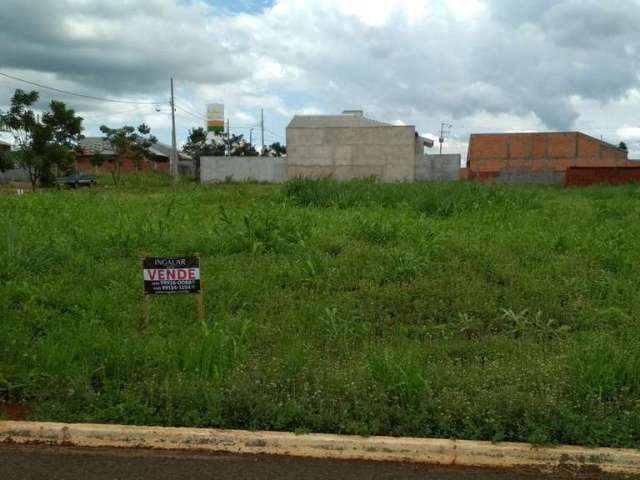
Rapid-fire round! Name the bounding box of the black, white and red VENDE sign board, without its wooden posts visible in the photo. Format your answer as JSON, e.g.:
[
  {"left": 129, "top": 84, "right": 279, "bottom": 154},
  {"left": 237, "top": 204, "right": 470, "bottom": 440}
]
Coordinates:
[{"left": 142, "top": 257, "right": 200, "bottom": 295}]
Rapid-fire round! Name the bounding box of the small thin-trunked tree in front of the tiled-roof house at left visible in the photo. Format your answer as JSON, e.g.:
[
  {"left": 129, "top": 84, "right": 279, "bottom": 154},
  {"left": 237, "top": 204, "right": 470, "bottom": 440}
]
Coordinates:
[{"left": 100, "top": 123, "right": 158, "bottom": 185}]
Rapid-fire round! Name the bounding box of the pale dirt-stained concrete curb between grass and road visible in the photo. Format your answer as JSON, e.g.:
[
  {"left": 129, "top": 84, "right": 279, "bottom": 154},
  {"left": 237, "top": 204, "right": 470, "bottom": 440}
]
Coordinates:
[{"left": 0, "top": 421, "right": 640, "bottom": 475}]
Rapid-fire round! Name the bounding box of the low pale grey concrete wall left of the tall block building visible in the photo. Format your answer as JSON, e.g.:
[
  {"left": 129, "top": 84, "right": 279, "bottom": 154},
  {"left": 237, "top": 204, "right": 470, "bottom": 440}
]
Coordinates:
[{"left": 200, "top": 157, "right": 287, "bottom": 183}]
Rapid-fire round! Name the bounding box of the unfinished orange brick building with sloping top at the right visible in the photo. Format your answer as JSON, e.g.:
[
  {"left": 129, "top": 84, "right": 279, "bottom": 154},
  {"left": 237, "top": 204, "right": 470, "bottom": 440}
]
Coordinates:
[{"left": 467, "top": 132, "right": 631, "bottom": 185}]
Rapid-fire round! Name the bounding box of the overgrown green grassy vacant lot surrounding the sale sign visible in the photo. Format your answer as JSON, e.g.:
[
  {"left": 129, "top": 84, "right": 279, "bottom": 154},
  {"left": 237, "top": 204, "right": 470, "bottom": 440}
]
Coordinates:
[{"left": 0, "top": 174, "right": 640, "bottom": 447}]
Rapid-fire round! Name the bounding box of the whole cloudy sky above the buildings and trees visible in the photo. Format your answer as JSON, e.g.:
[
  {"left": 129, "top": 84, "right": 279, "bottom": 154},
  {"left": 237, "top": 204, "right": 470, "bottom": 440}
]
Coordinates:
[{"left": 0, "top": 0, "right": 640, "bottom": 158}]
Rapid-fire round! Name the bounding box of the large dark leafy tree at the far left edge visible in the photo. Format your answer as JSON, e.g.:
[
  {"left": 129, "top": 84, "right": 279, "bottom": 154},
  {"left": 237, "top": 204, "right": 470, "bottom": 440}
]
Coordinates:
[{"left": 0, "top": 89, "right": 82, "bottom": 191}]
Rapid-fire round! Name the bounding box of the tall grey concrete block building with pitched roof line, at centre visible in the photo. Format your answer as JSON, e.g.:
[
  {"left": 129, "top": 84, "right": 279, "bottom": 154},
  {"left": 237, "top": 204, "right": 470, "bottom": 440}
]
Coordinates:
[{"left": 287, "top": 111, "right": 433, "bottom": 182}]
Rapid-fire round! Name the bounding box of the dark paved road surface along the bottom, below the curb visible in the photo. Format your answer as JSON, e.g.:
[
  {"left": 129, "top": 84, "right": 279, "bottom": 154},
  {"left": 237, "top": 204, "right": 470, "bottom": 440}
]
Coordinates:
[{"left": 0, "top": 444, "right": 598, "bottom": 480}]
